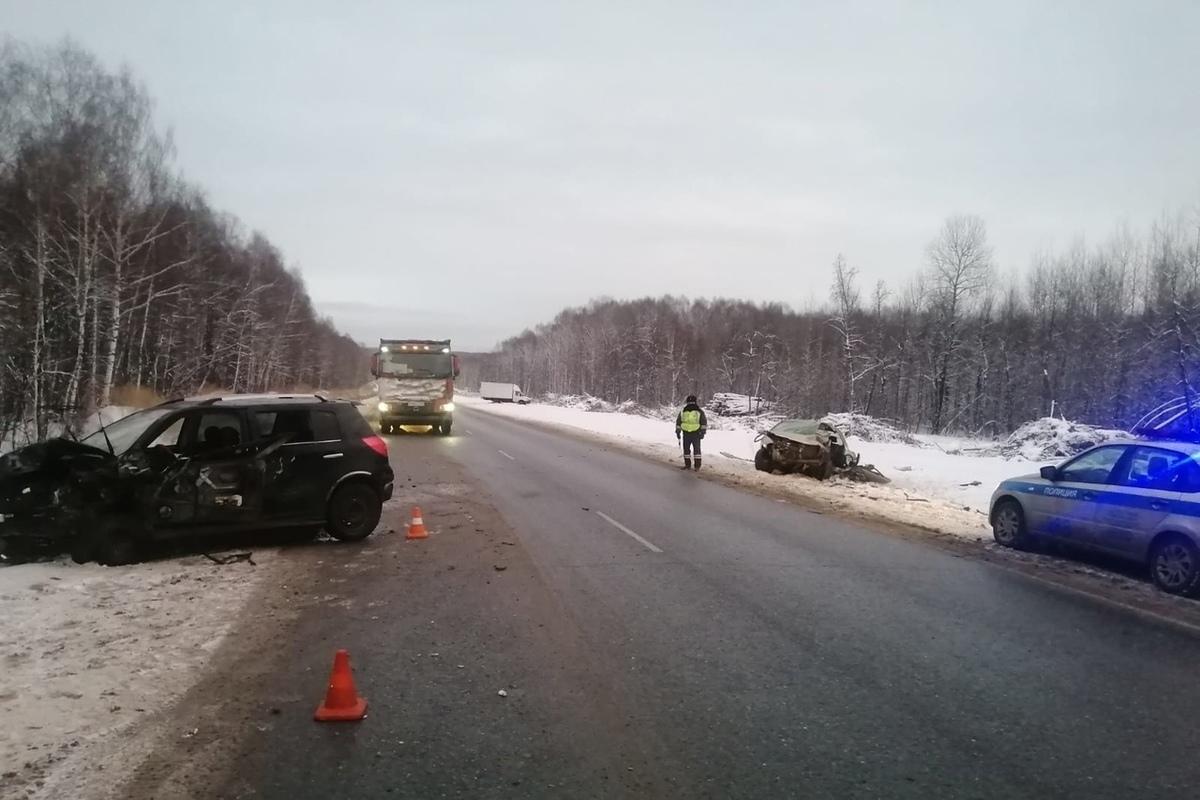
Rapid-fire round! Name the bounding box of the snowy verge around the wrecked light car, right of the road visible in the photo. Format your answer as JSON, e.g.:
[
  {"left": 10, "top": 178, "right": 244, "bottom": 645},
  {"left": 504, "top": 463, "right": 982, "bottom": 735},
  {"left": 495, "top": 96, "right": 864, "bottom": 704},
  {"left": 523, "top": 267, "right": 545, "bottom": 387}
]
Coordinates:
[{"left": 455, "top": 395, "right": 1039, "bottom": 539}]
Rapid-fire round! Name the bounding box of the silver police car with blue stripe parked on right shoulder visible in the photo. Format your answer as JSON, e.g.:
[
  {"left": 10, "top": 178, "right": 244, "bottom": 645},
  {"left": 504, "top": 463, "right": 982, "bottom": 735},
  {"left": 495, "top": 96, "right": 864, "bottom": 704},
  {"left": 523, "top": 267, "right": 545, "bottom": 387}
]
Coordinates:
[{"left": 990, "top": 440, "right": 1200, "bottom": 596}]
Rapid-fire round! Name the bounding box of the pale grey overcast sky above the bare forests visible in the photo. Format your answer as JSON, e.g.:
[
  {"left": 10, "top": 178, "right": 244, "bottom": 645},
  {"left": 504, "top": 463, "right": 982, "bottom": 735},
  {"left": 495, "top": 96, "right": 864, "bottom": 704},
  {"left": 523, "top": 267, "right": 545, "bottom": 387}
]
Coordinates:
[{"left": 0, "top": 0, "right": 1200, "bottom": 349}]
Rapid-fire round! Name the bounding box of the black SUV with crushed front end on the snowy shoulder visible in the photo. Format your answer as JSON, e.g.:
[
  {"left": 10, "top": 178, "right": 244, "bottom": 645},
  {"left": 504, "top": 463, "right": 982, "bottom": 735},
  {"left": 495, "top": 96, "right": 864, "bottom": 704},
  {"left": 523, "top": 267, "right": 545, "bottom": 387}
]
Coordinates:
[{"left": 0, "top": 395, "right": 392, "bottom": 565}]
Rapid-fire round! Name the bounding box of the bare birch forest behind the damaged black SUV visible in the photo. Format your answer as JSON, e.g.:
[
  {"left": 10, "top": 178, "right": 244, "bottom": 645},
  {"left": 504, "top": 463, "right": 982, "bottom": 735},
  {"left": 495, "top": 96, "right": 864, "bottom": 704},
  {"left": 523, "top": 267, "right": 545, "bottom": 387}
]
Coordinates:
[{"left": 0, "top": 41, "right": 366, "bottom": 439}]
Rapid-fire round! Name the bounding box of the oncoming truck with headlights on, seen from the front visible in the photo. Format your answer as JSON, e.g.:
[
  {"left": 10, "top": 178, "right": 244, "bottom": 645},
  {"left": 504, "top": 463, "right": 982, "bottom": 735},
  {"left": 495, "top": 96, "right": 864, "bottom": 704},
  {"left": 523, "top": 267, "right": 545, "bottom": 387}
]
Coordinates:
[{"left": 371, "top": 339, "right": 458, "bottom": 437}]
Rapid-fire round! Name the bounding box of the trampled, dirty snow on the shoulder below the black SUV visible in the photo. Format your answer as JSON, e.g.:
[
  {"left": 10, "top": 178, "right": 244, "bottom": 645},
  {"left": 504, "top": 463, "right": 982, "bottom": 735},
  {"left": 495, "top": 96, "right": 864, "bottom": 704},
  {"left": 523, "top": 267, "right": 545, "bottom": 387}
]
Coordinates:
[{"left": 0, "top": 549, "right": 280, "bottom": 800}]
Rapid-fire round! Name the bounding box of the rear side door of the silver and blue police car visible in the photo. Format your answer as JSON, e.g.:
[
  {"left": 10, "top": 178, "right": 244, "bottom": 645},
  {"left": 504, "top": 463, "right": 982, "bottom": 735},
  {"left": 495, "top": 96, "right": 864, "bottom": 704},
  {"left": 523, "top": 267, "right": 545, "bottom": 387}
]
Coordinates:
[{"left": 1087, "top": 446, "right": 1188, "bottom": 555}]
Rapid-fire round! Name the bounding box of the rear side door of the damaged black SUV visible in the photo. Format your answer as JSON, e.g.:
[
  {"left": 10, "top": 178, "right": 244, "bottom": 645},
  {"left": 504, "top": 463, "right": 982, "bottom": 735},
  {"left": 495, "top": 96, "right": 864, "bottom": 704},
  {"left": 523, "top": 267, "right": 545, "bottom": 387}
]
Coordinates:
[{"left": 253, "top": 407, "right": 346, "bottom": 523}]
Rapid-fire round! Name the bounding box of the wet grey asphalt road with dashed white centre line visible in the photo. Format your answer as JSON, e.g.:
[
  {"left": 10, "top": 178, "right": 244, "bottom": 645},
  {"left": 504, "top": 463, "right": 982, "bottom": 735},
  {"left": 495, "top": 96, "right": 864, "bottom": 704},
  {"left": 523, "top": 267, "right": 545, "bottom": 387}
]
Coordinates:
[{"left": 204, "top": 409, "right": 1200, "bottom": 799}]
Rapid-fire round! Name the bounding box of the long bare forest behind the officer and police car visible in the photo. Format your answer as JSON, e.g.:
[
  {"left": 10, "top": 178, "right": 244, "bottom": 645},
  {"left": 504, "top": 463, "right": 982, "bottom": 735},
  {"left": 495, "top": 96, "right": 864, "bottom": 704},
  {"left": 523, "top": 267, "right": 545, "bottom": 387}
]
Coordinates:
[{"left": 481, "top": 215, "right": 1200, "bottom": 435}]
